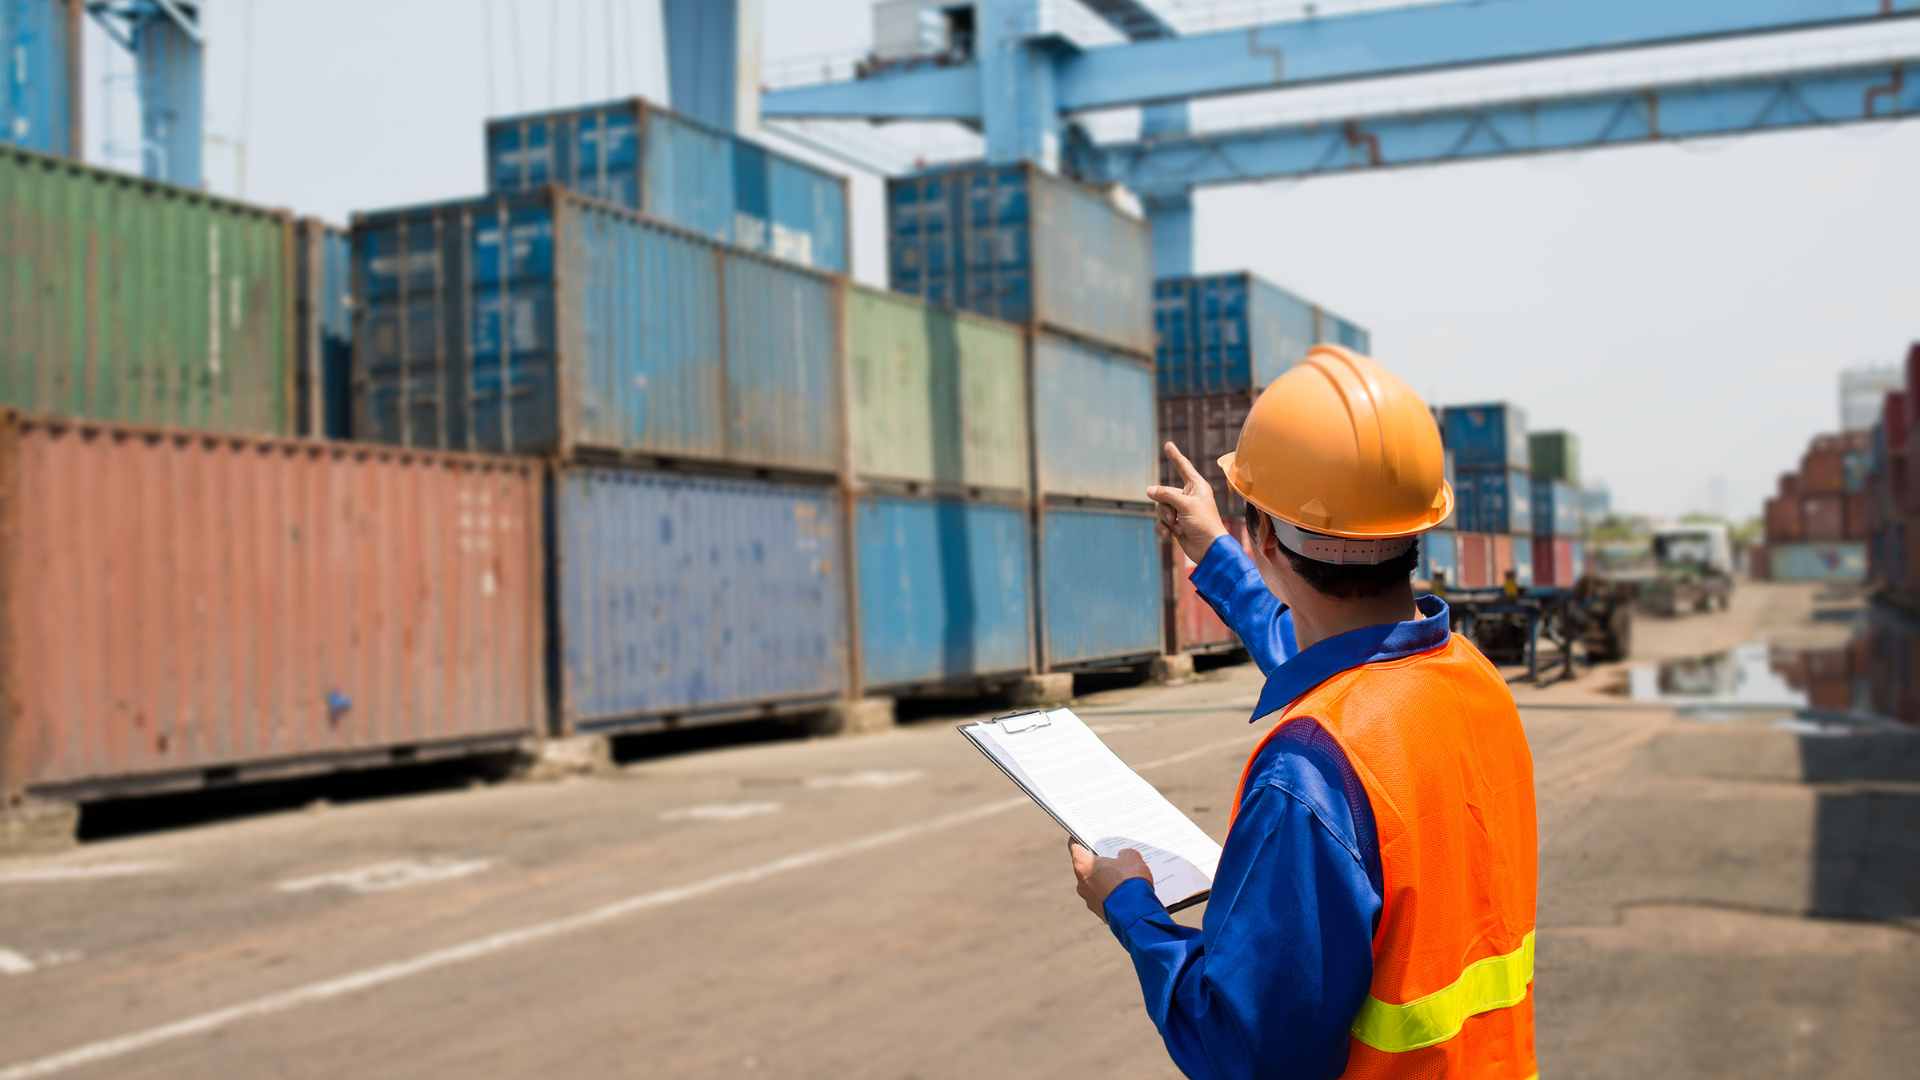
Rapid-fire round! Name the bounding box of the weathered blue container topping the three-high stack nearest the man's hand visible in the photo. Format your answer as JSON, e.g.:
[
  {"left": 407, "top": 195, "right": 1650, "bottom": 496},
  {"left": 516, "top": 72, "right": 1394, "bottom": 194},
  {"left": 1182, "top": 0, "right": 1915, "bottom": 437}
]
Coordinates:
[{"left": 887, "top": 163, "right": 1154, "bottom": 356}]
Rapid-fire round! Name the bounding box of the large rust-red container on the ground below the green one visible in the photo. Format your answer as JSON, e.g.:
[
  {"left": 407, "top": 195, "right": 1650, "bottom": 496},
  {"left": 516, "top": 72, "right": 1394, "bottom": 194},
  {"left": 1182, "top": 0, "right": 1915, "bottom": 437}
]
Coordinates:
[{"left": 0, "top": 413, "right": 545, "bottom": 801}]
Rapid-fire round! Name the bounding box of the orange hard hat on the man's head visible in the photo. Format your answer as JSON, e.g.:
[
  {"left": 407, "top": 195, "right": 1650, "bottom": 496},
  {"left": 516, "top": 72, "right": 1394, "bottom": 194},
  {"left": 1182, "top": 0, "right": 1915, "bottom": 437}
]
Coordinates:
[{"left": 1219, "top": 346, "right": 1453, "bottom": 563}]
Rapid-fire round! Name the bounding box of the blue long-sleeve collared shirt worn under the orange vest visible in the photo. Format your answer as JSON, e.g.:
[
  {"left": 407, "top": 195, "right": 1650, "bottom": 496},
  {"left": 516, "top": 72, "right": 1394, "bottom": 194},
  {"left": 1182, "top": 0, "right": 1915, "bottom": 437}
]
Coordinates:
[{"left": 1106, "top": 536, "right": 1448, "bottom": 1078}]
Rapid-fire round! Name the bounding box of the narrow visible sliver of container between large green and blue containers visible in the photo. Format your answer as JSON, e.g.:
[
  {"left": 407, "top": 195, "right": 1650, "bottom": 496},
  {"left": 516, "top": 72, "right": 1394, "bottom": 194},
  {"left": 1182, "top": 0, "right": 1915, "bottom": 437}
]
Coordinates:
[{"left": 294, "top": 217, "right": 353, "bottom": 438}]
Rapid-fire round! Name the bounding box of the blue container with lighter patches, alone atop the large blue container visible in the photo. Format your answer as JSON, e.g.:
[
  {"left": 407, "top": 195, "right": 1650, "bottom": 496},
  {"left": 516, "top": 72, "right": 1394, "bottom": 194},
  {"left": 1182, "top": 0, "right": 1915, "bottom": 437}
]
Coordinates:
[{"left": 486, "top": 98, "right": 852, "bottom": 273}]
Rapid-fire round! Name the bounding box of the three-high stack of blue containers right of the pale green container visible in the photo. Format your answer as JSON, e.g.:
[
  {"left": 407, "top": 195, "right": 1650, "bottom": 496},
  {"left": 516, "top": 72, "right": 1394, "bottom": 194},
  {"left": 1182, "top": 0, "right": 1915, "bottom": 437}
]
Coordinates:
[{"left": 887, "top": 163, "right": 1165, "bottom": 671}]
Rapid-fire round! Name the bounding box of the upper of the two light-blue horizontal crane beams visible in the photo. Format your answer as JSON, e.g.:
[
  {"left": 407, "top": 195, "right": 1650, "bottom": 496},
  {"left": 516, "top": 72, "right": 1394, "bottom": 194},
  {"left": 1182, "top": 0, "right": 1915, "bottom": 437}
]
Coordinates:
[{"left": 762, "top": 0, "right": 1920, "bottom": 121}]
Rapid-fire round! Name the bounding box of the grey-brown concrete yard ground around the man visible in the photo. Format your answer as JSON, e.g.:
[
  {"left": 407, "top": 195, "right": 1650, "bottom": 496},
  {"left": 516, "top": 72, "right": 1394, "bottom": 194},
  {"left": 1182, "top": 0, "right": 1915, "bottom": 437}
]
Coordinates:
[{"left": 0, "top": 586, "right": 1920, "bottom": 1080}]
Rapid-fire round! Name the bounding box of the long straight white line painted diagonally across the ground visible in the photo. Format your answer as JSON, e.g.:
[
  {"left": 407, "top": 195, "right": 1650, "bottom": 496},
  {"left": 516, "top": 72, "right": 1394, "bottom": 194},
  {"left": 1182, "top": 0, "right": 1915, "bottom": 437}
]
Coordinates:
[{"left": 0, "top": 734, "right": 1250, "bottom": 1080}]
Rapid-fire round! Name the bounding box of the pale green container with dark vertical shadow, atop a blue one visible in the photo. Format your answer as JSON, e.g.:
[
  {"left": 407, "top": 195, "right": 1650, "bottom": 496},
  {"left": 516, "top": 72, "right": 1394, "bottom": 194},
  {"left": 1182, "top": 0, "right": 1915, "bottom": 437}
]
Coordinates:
[{"left": 847, "top": 286, "right": 1031, "bottom": 492}]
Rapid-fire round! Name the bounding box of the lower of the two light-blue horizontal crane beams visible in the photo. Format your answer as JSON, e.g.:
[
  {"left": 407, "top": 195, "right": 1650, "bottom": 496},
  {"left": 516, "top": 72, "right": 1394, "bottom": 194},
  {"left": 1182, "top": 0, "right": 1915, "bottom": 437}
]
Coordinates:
[{"left": 1092, "top": 61, "right": 1920, "bottom": 198}]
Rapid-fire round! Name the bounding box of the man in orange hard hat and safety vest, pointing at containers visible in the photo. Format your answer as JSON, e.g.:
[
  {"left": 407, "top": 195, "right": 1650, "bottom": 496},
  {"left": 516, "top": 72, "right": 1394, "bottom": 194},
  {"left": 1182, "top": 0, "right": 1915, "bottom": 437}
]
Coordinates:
[{"left": 1069, "top": 346, "right": 1538, "bottom": 1080}]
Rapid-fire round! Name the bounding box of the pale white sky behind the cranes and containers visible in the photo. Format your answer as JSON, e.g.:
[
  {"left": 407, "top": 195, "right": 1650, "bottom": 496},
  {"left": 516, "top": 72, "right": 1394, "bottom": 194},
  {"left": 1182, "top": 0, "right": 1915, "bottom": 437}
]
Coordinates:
[{"left": 88, "top": 0, "right": 1920, "bottom": 515}]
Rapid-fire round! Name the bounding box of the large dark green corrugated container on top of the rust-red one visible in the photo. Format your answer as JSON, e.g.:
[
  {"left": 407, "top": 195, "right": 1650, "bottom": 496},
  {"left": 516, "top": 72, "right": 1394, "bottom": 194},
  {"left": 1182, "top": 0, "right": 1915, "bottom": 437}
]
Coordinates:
[{"left": 0, "top": 146, "right": 294, "bottom": 434}]
